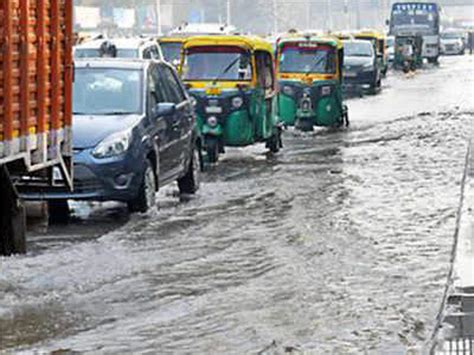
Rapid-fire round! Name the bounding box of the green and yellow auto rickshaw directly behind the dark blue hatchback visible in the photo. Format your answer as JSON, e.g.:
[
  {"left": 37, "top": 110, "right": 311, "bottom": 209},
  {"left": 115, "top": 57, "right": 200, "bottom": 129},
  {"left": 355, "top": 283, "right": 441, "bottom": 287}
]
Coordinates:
[{"left": 181, "top": 35, "right": 281, "bottom": 163}]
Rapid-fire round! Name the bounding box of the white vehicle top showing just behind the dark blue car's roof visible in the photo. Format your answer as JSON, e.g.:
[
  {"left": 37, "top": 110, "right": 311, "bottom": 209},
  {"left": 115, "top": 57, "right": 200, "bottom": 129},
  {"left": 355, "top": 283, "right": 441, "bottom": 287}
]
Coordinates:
[{"left": 74, "top": 38, "right": 164, "bottom": 61}]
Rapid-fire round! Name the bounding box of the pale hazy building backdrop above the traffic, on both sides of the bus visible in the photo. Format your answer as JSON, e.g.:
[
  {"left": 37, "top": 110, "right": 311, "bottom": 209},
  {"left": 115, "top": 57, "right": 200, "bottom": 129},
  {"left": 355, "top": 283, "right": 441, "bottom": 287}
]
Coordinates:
[{"left": 74, "top": 0, "right": 474, "bottom": 34}]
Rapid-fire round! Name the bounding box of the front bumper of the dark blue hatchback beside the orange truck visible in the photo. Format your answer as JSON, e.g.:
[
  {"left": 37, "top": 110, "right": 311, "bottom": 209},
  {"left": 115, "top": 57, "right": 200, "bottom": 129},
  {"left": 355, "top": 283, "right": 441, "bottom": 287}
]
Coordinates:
[{"left": 22, "top": 152, "right": 144, "bottom": 202}]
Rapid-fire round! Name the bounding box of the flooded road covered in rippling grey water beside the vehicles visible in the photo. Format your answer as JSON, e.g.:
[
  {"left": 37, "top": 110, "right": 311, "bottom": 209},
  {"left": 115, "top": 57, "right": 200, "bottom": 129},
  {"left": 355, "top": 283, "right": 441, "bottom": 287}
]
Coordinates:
[{"left": 0, "top": 56, "right": 474, "bottom": 354}]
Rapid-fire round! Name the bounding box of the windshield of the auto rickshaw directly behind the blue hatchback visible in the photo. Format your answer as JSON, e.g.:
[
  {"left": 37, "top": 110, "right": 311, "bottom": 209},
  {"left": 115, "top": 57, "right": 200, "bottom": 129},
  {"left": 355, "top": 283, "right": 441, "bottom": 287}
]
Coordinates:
[{"left": 183, "top": 47, "right": 252, "bottom": 81}]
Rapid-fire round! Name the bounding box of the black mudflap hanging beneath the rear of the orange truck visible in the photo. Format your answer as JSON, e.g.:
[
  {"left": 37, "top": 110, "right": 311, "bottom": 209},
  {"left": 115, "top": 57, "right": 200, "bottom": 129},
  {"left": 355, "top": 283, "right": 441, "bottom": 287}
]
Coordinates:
[{"left": 0, "top": 165, "right": 26, "bottom": 256}]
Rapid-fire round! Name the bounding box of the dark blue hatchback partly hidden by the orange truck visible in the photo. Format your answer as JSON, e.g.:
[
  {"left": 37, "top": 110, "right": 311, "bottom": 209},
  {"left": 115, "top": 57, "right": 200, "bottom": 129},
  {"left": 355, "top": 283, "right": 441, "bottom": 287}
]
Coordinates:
[{"left": 25, "top": 59, "right": 201, "bottom": 213}]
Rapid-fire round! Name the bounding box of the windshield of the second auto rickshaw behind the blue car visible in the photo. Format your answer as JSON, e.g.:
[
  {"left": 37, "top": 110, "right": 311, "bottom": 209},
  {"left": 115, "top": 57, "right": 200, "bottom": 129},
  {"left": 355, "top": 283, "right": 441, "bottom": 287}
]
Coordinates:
[{"left": 280, "top": 43, "right": 336, "bottom": 74}]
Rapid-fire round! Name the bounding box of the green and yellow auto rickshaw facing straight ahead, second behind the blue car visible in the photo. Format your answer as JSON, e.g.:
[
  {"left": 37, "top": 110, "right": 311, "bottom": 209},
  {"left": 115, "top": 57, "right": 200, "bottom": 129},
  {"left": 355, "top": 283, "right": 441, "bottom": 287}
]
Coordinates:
[{"left": 277, "top": 35, "right": 349, "bottom": 131}]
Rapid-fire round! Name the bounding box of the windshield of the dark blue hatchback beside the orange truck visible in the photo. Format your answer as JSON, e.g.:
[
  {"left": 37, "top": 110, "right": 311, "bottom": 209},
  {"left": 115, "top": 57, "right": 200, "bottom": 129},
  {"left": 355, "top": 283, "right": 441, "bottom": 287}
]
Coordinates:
[{"left": 73, "top": 68, "right": 143, "bottom": 115}]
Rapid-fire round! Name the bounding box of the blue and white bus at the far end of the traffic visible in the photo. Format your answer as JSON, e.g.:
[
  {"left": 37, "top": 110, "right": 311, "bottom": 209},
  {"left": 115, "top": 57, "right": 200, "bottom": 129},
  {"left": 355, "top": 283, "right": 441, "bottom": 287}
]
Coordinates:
[{"left": 389, "top": 2, "right": 441, "bottom": 63}]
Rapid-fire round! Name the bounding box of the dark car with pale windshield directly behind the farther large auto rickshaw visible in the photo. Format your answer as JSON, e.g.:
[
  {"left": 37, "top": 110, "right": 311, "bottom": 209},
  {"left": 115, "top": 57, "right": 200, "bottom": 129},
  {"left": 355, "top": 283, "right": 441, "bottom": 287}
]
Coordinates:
[{"left": 344, "top": 40, "right": 382, "bottom": 94}]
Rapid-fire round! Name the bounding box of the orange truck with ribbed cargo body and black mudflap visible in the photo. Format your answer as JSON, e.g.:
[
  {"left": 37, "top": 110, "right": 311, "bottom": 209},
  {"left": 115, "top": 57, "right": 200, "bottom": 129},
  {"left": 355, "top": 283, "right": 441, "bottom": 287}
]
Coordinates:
[{"left": 0, "top": 0, "right": 74, "bottom": 255}]
